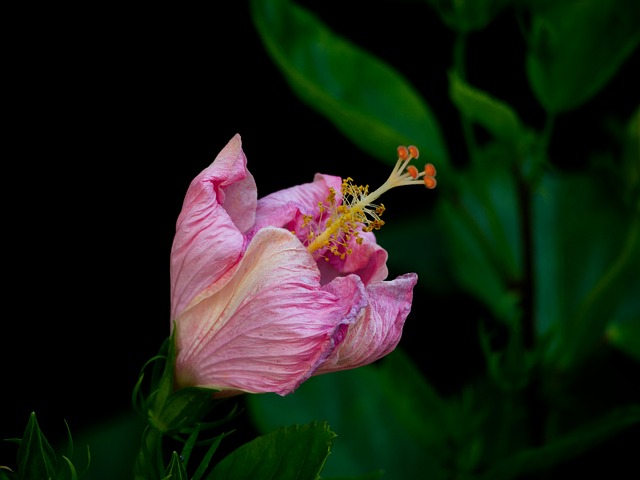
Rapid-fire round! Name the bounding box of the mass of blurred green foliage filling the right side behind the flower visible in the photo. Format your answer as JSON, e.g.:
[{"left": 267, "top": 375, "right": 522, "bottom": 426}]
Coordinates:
[{"left": 249, "top": 0, "right": 640, "bottom": 480}]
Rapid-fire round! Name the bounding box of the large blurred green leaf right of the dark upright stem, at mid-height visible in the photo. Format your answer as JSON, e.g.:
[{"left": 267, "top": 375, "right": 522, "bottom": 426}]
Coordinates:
[{"left": 534, "top": 174, "right": 640, "bottom": 369}]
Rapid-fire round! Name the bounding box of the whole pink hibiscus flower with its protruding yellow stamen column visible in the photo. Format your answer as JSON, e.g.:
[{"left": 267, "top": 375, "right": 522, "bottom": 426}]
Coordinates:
[{"left": 171, "top": 135, "right": 435, "bottom": 396}]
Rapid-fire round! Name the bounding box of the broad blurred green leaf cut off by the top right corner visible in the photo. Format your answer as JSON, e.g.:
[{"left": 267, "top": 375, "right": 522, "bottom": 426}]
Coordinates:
[{"left": 526, "top": 0, "right": 640, "bottom": 113}]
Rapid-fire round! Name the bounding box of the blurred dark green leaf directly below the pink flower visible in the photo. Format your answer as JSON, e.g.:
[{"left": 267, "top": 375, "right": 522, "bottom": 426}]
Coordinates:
[{"left": 246, "top": 365, "right": 432, "bottom": 480}]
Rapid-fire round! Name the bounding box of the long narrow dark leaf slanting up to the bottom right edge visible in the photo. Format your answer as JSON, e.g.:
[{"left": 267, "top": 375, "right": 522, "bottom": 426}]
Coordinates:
[{"left": 479, "top": 405, "right": 640, "bottom": 480}]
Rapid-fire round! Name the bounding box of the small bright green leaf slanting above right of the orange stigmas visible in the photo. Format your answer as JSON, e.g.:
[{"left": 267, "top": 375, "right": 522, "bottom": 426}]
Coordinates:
[{"left": 449, "top": 72, "right": 526, "bottom": 145}]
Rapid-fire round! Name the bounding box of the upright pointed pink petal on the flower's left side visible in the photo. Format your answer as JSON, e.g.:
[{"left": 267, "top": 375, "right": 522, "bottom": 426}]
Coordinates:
[{"left": 171, "top": 135, "right": 257, "bottom": 319}]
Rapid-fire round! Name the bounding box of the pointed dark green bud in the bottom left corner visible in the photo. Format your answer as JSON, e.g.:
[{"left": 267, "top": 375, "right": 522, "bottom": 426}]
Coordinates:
[{"left": 18, "top": 412, "right": 57, "bottom": 480}]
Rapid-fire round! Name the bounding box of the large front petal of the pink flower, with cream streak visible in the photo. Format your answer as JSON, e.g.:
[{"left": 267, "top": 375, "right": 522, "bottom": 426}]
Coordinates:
[{"left": 176, "top": 227, "right": 367, "bottom": 395}]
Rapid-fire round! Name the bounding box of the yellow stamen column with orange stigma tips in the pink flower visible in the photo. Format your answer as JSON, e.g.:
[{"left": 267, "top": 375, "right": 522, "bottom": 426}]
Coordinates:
[{"left": 297, "top": 145, "right": 437, "bottom": 261}]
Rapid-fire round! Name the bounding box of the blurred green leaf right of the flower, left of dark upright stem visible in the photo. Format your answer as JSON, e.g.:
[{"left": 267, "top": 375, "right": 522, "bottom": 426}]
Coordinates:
[{"left": 436, "top": 143, "right": 522, "bottom": 323}]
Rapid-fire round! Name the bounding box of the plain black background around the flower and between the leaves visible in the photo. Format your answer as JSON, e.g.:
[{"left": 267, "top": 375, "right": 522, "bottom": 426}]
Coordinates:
[{"left": 0, "top": 1, "right": 640, "bottom": 472}]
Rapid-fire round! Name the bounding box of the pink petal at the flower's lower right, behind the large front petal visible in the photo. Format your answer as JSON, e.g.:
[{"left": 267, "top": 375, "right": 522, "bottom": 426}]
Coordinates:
[{"left": 316, "top": 273, "right": 418, "bottom": 374}]
